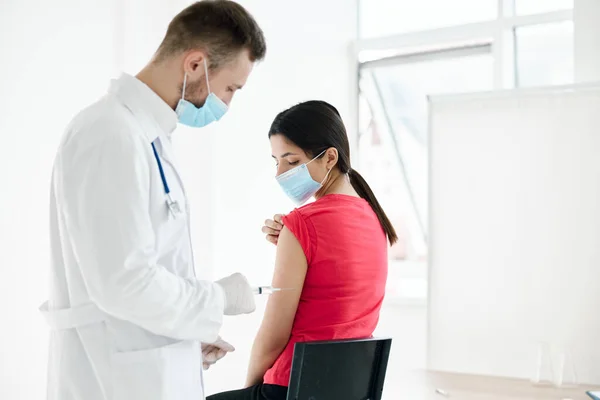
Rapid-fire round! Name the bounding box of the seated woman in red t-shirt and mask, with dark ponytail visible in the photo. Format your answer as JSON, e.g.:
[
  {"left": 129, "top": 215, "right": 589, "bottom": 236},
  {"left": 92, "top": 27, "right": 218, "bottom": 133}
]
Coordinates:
[{"left": 208, "top": 101, "right": 397, "bottom": 400}]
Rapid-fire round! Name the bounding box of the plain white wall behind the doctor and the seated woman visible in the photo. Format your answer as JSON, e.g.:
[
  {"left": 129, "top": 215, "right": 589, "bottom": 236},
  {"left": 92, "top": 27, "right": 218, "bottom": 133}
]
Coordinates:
[{"left": 0, "top": 0, "right": 357, "bottom": 400}]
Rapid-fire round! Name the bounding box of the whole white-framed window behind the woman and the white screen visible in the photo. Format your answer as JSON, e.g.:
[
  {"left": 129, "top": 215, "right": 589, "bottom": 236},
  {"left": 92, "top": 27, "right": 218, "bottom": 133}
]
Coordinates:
[{"left": 357, "top": 0, "right": 573, "bottom": 298}]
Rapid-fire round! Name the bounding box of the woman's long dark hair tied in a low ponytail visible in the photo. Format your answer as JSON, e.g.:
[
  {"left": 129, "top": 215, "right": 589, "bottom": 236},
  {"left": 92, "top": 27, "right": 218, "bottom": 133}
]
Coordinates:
[{"left": 269, "top": 100, "right": 398, "bottom": 244}]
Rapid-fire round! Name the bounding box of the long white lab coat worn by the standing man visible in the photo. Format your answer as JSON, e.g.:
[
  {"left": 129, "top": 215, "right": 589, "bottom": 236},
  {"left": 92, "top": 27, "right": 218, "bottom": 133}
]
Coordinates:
[{"left": 41, "top": 75, "right": 224, "bottom": 400}]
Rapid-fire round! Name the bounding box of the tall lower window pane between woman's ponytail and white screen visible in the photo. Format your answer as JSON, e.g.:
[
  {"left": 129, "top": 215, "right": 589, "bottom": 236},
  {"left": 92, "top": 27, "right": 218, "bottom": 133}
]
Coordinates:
[{"left": 359, "top": 50, "right": 494, "bottom": 299}]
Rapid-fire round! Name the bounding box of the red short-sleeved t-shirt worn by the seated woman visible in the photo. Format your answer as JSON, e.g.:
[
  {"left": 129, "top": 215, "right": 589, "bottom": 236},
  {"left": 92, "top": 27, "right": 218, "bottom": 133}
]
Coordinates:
[{"left": 264, "top": 194, "right": 388, "bottom": 386}]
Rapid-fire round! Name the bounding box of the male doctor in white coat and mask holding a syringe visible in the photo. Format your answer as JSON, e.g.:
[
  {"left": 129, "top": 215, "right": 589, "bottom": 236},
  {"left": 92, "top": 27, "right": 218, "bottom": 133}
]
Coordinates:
[{"left": 41, "top": 0, "right": 266, "bottom": 400}]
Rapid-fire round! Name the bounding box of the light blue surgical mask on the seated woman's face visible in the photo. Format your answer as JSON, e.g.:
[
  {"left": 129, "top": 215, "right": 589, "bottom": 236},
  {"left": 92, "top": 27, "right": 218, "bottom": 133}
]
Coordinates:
[{"left": 275, "top": 150, "right": 331, "bottom": 206}]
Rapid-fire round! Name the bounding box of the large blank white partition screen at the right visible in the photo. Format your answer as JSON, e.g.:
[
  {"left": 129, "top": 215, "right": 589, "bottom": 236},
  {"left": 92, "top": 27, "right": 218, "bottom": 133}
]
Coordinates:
[{"left": 428, "top": 86, "right": 600, "bottom": 384}]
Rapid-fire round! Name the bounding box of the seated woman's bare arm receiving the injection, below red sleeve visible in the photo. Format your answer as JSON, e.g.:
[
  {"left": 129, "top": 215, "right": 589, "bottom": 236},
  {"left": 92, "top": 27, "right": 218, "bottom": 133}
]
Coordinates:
[{"left": 246, "top": 227, "right": 307, "bottom": 387}]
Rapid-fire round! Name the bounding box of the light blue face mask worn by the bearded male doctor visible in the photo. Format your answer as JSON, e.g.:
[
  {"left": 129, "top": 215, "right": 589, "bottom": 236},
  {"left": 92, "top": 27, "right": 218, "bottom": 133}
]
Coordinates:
[{"left": 175, "top": 58, "right": 229, "bottom": 128}]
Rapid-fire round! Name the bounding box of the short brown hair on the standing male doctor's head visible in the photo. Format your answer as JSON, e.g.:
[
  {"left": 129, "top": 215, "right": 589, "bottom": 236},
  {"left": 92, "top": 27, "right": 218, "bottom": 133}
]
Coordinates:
[{"left": 156, "top": 0, "right": 267, "bottom": 69}]
